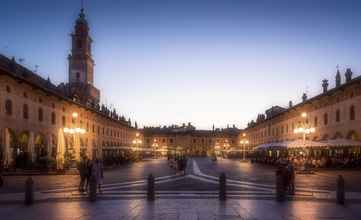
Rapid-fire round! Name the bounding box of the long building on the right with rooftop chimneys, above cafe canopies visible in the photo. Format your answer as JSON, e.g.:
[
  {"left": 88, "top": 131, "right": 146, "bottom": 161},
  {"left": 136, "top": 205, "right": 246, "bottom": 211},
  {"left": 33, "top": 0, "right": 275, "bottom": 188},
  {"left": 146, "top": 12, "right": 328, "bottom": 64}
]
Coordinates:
[{"left": 245, "top": 69, "right": 361, "bottom": 147}]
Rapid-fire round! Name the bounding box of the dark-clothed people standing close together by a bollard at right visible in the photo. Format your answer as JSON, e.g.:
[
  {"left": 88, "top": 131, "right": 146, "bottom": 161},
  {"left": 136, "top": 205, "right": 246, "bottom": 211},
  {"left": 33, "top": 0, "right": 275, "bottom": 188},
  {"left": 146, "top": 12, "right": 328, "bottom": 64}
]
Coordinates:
[{"left": 276, "top": 161, "right": 296, "bottom": 195}]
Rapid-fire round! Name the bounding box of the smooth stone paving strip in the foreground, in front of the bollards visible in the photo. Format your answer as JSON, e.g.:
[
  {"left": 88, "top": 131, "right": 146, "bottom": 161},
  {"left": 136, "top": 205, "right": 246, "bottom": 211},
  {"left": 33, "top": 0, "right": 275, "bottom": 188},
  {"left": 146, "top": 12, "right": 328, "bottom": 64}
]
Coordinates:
[{"left": 0, "top": 199, "right": 361, "bottom": 220}]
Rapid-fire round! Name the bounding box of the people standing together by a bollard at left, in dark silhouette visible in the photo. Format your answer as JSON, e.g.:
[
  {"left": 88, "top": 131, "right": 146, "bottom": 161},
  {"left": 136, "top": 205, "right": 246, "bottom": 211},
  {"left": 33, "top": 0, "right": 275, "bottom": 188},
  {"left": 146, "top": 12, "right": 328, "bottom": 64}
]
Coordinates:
[{"left": 78, "top": 157, "right": 104, "bottom": 193}]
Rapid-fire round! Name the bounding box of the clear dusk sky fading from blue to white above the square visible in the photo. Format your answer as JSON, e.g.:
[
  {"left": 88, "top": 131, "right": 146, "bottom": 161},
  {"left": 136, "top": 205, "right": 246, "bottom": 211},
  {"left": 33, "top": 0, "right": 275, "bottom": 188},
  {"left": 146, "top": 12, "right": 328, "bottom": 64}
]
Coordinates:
[{"left": 0, "top": 0, "right": 361, "bottom": 129}]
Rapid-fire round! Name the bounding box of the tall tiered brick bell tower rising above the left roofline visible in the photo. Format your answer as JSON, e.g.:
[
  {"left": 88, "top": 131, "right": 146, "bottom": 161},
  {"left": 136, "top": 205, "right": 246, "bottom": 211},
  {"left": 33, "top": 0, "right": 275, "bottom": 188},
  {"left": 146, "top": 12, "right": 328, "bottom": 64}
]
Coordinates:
[{"left": 66, "top": 7, "right": 100, "bottom": 105}]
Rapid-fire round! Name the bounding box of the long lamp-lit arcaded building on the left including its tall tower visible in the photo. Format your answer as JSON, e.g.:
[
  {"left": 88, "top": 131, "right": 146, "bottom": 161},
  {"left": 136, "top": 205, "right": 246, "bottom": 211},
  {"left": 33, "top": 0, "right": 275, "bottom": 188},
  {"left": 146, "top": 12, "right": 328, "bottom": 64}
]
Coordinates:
[{"left": 0, "top": 10, "right": 137, "bottom": 168}]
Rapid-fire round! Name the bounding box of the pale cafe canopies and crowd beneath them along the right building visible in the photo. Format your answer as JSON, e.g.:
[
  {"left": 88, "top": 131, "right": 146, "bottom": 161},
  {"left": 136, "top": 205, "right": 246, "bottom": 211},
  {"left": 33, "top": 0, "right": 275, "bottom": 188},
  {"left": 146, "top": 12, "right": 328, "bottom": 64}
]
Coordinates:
[{"left": 252, "top": 139, "right": 361, "bottom": 168}]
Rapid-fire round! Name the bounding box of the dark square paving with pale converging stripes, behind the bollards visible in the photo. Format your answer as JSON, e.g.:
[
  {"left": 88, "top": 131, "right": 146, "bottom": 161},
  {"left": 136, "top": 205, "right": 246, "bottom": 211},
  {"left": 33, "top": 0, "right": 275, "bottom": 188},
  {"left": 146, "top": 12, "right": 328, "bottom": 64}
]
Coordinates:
[{"left": 0, "top": 158, "right": 361, "bottom": 204}]
